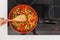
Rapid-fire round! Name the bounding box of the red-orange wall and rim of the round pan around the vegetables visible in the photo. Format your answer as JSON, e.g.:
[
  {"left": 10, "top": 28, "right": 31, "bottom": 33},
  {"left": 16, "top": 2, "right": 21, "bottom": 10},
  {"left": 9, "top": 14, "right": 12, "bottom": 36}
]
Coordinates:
[{"left": 8, "top": 4, "right": 38, "bottom": 34}]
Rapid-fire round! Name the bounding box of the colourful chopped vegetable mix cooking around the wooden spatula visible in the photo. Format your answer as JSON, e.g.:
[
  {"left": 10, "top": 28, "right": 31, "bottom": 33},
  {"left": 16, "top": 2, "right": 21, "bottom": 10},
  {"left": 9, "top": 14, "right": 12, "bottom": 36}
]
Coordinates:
[{"left": 12, "top": 7, "right": 37, "bottom": 32}]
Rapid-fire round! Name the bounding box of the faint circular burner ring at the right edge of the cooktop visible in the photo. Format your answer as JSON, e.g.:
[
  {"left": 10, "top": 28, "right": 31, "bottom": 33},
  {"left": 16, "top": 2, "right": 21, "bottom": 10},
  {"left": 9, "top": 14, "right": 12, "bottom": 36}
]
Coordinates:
[{"left": 49, "top": 5, "right": 60, "bottom": 20}]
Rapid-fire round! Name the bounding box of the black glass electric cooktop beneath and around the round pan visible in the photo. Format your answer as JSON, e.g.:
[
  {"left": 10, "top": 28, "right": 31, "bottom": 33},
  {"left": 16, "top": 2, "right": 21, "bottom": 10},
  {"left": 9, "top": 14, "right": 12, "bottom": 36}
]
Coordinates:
[{"left": 8, "top": 0, "right": 60, "bottom": 35}]
